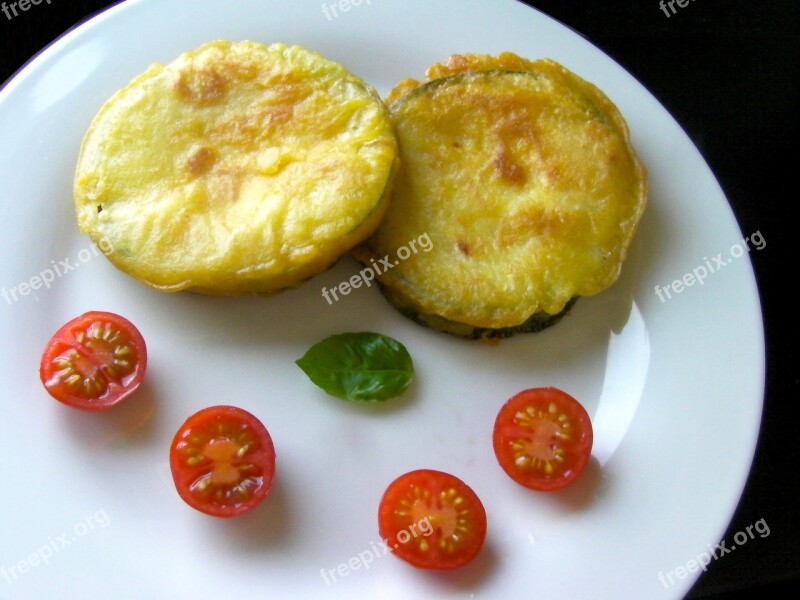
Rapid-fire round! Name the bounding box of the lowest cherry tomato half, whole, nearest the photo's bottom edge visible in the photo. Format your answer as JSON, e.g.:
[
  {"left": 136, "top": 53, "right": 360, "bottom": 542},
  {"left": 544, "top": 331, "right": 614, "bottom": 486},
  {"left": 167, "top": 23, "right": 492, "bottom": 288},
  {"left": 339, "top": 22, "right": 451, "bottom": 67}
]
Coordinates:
[{"left": 378, "top": 469, "right": 486, "bottom": 570}]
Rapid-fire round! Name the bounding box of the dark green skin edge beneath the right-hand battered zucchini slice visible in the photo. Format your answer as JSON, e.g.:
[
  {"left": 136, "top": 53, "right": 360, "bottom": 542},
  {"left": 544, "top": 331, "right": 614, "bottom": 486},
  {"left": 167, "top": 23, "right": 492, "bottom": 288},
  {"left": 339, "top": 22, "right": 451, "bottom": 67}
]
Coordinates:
[{"left": 378, "top": 281, "right": 579, "bottom": 341}]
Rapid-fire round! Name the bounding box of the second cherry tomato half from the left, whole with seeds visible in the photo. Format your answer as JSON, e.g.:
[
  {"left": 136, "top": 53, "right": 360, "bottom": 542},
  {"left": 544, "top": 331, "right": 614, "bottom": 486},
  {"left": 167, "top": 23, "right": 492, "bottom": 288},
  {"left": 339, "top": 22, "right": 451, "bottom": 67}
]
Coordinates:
[{"left": 169, "top": 406, "right": 275, "bottom": 517}]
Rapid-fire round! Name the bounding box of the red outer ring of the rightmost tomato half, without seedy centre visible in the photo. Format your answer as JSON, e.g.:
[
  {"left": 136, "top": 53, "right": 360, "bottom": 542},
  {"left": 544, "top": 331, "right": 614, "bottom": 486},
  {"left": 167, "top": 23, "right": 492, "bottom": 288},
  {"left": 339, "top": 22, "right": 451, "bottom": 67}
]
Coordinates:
[{"left": 492, "top": 387, "right": 594, "bottom": 492}]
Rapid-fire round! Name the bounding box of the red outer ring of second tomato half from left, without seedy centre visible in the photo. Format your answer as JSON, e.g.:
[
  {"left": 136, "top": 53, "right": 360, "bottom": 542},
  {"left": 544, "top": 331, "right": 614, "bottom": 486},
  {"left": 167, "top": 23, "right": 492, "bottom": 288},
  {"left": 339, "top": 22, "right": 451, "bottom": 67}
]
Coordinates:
[{"left": 169, "top": 405, "right": 275, "bottom": 519}]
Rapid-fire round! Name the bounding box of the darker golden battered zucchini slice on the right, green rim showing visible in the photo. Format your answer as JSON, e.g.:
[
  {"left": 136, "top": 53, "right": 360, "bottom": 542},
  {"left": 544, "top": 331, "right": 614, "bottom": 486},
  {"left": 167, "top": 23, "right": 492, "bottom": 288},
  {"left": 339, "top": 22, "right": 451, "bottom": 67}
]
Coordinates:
[{"left": 354, "top": 53, "right": 647, "bottom": 339}]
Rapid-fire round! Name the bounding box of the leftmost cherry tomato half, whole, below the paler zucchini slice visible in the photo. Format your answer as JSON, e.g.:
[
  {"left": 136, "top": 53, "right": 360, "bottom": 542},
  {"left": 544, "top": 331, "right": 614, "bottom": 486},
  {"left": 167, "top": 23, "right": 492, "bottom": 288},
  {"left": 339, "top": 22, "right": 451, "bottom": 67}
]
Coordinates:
[{"left": 39, "top": 311, "right": 147, "bottom": 410}]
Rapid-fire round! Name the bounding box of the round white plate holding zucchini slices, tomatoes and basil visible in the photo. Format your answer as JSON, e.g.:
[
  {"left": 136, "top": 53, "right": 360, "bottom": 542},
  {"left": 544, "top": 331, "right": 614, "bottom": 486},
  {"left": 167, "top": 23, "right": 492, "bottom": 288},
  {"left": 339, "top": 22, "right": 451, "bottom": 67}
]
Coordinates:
[{"left": 0, "top": 0, "right": 764, "bottom": 600}]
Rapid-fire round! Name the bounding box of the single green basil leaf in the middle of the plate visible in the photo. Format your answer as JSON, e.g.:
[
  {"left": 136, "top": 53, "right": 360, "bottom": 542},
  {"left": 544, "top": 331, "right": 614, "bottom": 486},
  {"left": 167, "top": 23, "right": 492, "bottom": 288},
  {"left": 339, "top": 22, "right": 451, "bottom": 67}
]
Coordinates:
[{"left": 295, "top": 331, "right": 414, "bottom": 402}]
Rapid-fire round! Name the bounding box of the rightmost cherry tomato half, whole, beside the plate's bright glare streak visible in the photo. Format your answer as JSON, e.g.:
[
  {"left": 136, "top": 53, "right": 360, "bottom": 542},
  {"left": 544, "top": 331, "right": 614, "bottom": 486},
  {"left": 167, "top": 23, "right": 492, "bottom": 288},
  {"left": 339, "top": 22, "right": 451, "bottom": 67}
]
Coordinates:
[{"left": 492, "top": 387, "right": 593, "bottom": 492}]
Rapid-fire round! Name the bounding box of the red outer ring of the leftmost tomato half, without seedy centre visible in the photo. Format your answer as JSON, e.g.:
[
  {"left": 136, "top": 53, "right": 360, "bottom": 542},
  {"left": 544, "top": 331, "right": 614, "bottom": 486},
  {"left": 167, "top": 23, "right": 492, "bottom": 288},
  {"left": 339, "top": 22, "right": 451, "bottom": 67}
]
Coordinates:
[{"left": 39, "top": 310, "right": 147, "bottom": 412}]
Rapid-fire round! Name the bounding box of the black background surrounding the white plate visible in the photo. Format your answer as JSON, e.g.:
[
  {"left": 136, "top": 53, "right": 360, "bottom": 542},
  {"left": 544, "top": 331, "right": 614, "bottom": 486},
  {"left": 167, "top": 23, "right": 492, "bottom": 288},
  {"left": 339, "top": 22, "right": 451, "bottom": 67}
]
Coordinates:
[{"left": 0, "top": 0, "right": 800, "bottom": 599}]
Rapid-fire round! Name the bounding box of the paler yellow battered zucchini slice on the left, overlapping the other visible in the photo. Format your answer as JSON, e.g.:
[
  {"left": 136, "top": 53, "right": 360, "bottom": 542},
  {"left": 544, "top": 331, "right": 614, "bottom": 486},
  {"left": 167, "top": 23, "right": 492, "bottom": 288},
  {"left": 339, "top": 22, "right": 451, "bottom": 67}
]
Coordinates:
[{"left": 74, "top": 41, "right": 397, "bottom": 295}]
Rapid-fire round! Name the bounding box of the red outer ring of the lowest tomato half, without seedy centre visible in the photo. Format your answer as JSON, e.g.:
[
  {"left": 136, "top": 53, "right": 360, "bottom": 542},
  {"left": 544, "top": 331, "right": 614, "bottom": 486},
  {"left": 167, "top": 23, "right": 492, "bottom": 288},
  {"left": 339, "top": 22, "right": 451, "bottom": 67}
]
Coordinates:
[{"left": 378, "top": 469, "right": 487, "bottom": 571}]
